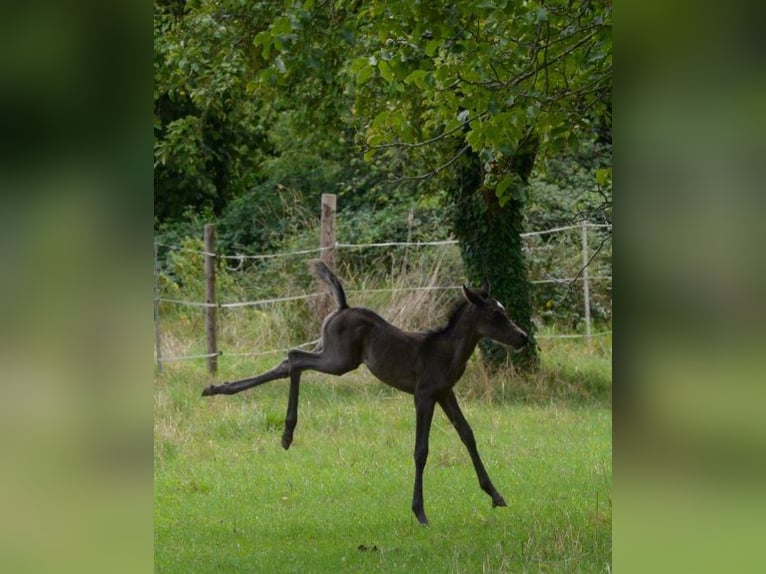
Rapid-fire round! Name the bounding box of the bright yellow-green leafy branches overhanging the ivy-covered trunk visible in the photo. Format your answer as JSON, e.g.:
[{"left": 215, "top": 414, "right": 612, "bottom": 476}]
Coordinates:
[{"left": 352, "top": 0, "right": 611, "bottom": 197}]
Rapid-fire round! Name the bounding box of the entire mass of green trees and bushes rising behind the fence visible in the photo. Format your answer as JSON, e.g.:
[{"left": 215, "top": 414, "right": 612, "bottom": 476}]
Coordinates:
[{"left": 154, "top": 0, "right": 611, "bottom": 358}]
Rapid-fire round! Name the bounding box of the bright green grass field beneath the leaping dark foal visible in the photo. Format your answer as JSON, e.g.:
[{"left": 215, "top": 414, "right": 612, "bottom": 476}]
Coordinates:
[{"left": 154, "top": 332, "right": 612, "bottom": 573}]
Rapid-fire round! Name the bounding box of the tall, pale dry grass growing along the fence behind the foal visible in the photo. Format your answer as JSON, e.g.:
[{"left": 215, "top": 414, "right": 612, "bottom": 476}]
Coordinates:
[{"left": 156, "top": 241, "right": 612, "bottom": 404}]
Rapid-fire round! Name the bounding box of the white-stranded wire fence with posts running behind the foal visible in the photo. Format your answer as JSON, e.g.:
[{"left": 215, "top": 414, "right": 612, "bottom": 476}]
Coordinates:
[{"left": 154, "top": 198, "right": 612, "bottom": 372}]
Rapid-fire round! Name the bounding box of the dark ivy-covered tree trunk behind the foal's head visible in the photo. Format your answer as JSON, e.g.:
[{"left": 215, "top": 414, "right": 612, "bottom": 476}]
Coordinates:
[{"left": 449, "top": 134, "right": 539, "bottom": 371}]
